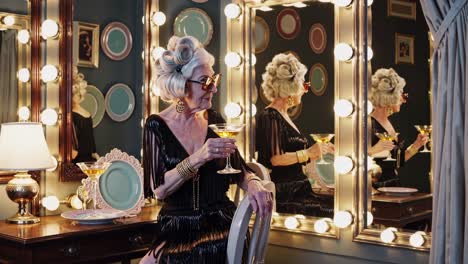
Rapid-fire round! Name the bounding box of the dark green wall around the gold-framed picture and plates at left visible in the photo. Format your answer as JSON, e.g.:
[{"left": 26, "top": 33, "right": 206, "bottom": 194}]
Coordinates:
[{"left": 73, "top": 0, "right": 144, "bottom": 159}]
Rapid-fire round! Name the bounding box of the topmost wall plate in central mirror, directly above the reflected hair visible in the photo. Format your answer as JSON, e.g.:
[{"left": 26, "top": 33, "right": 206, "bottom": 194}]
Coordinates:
[{"left": 276, "top": 8, "right": 301, "bottom": 39}]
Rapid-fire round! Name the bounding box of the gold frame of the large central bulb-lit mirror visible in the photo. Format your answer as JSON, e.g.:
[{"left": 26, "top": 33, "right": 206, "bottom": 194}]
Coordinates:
[{"left": 226, "top": 0, "right": 359, "bottom": 238}]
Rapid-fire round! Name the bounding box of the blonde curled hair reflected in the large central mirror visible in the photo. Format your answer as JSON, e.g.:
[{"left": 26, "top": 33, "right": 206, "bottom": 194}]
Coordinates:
[{"left": 262, "top": 53, "right": 307, "bottom": 101}]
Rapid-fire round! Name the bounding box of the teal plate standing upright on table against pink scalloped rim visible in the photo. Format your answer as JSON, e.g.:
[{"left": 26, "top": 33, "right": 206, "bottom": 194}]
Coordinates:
[{"left": 99, "top": 160, "right": 142, "bottom": 210}]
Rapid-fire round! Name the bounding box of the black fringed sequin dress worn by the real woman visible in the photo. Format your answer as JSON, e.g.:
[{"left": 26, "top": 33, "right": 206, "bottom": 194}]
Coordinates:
[{"left": 143, "top": 110, "right": 250, "bottom": 264}]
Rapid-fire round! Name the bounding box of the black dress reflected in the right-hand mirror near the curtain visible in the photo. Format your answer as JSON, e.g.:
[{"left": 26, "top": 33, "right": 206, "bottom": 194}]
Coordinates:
[{"left": 371, "top": 117, "right": 405, "bottom": 189}]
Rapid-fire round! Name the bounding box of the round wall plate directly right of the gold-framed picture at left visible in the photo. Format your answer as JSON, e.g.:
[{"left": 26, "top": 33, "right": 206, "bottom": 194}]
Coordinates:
[{"left": 101, "top": 22, "right": 133, "bottom": 60}]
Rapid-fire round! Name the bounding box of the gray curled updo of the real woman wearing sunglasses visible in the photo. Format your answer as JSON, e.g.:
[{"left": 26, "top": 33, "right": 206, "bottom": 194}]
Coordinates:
[{"left": 154, "top": 36, "right": 218, "bottom": 101}]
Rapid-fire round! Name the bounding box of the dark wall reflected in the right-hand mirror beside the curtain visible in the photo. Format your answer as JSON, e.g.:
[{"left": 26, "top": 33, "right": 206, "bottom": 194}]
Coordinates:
[{"left": 372, "top": 1, "right": 431, "bottom": 192}]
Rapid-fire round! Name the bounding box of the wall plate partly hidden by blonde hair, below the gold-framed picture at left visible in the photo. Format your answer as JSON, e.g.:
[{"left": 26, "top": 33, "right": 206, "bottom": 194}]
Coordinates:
[{"left": 80, "top": 85, "right": 105, "bottom": 127}]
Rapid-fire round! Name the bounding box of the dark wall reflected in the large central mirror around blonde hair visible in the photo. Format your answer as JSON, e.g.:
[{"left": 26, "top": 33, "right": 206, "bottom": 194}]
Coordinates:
[{"left": 255, "top": 2, "right": 335, "bottom": 140}]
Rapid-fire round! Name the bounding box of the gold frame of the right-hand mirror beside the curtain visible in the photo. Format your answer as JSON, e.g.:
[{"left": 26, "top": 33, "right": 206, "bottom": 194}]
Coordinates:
[{"left": 353, "top": 1, "right": 431, "bottom": 252}]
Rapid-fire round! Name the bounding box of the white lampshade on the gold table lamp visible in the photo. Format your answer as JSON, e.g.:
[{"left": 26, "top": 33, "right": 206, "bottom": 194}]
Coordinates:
[{"left": 0, "top": 122, "right": 54, "bottom": 171}]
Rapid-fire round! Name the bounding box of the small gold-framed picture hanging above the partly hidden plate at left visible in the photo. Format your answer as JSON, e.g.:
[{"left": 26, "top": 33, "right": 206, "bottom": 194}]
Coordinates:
[{"left": 73, "top": 21, "right": 99, "bottom": 68}]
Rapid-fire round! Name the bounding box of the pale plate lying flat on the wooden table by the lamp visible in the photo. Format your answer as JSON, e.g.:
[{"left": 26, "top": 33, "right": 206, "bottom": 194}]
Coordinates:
[{"left": 61, "top": 209, "right": 125, "bottom": 225}]
